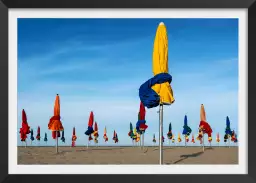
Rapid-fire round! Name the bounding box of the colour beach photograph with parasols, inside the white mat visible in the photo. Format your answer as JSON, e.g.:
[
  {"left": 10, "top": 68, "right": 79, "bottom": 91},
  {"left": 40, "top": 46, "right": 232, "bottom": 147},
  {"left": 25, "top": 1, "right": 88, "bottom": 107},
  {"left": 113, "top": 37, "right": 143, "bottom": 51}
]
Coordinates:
[{"left": 17, "top": 18, "right": 240, "bottom": 166}]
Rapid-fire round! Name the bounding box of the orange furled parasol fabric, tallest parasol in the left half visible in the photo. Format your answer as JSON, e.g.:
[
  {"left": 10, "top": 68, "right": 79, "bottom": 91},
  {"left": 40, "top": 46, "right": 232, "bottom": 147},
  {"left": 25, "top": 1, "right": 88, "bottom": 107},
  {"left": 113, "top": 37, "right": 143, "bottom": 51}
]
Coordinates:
[{"left": 48, "top": 94, "right": 64, "bottom": 139}]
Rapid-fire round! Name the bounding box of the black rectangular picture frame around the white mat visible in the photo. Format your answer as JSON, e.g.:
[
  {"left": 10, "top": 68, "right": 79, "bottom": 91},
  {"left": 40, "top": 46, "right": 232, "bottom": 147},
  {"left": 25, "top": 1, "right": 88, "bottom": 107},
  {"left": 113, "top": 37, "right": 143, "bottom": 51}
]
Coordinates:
[{"left": 0, "top": 0, "right": 256, "bottom": 183}]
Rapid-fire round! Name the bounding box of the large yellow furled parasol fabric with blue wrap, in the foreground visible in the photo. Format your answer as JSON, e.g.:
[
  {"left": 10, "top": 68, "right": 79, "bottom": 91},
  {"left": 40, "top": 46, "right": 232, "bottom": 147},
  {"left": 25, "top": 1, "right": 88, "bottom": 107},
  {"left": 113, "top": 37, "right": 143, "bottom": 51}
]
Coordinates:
[{"left": 139, "top": 22, "right": 174, "bottom": 108}]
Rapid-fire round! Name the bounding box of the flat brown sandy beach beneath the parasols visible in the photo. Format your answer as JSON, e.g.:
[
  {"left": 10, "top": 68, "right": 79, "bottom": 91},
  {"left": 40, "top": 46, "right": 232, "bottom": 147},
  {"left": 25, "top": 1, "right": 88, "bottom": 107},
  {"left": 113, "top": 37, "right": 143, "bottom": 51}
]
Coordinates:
[{"left": 17, "top": 146, "right": 238, "bottom": 164}]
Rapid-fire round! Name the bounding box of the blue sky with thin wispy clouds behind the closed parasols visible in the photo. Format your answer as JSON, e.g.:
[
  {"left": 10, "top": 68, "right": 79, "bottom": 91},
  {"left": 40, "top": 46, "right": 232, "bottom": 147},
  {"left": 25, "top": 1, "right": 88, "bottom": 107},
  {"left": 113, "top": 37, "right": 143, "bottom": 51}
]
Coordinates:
[{"left": 17, "top": 19, "right": 239, "bottom": 145}]
